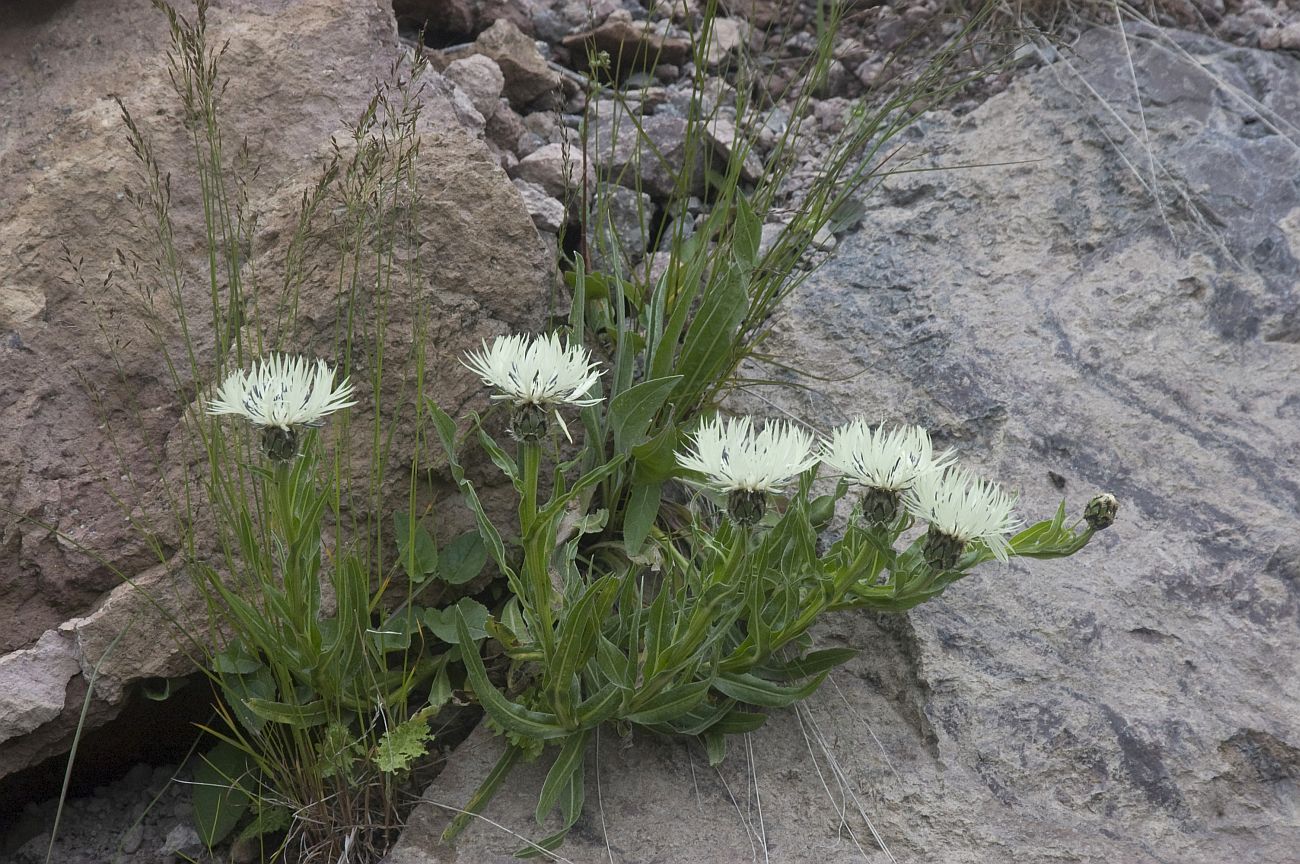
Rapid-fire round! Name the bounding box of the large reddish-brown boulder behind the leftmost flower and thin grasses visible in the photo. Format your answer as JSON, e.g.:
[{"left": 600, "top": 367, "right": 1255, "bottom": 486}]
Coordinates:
[{"left": 0, "top": 0, "right": 551, "bottom": 777}]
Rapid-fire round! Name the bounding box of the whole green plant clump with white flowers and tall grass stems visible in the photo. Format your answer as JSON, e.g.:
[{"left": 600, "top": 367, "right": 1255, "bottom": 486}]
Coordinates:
[{"left": 65, "top": 0, "right": 1115, "bottom": 861}]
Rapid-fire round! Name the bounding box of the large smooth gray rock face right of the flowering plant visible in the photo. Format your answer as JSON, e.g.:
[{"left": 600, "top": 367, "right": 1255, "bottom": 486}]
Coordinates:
[{"left": 390, "top": 23, "right": 1300, "bottom": 864}]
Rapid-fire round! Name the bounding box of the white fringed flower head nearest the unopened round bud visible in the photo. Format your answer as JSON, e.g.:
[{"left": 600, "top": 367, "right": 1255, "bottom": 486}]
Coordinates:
[{"left": 902, "top": 468, "right": 1021, "bottom": 570}]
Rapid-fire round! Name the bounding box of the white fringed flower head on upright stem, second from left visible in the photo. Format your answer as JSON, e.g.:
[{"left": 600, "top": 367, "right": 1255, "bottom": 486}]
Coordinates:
[{"left": 463, "top": 333, "right": 602, "bottom": 442}]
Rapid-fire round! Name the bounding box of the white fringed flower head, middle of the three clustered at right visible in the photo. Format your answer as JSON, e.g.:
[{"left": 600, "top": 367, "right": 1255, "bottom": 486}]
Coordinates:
[{"left": 822, "top": 418, "right": 954, "bottom": 524}]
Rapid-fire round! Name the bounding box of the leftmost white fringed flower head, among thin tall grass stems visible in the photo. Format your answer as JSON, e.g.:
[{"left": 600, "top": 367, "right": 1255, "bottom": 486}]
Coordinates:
[{"left": 208, "top": 353, "right": 356, "bottom": 461}]
